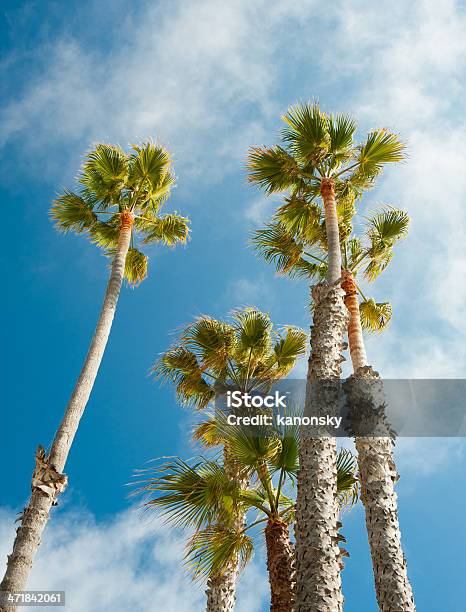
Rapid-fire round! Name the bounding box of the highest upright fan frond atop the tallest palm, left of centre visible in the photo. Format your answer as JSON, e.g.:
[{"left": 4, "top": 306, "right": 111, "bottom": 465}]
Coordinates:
[{"left": 282, "top": 102, "right": 331, "bottom": 166}]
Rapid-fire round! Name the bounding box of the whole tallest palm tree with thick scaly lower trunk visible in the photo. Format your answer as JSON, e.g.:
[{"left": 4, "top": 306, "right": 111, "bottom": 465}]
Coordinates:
[{"left": 248, "top": 103, "right": 404, "bottom": 612}]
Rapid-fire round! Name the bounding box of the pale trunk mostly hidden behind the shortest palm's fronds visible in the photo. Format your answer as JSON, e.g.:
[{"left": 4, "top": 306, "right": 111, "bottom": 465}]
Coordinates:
[{"left": 205, "top": 447, "right": 248, "bottom": 612}]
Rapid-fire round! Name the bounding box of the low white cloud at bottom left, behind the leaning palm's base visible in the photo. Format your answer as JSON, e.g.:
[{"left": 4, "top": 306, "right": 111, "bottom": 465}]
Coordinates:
[{"left": 0, "top": 509, "right": 268, "bottom": 612}]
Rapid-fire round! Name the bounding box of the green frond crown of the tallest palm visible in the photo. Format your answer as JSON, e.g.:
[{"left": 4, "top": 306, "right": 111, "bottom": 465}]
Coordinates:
[{"left": 248, "top": 102, "right": 405, "bottom": 204}]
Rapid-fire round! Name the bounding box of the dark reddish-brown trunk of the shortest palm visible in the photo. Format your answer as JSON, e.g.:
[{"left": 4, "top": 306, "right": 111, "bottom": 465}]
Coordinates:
[{"left": 265, "top": 519, "right": 295, "bottom": 612}]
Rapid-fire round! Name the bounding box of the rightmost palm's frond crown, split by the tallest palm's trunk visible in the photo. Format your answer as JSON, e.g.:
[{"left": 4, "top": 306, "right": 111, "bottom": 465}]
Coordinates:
[{"left": 252, "top": 207, "right": 409, "bottom": 331}]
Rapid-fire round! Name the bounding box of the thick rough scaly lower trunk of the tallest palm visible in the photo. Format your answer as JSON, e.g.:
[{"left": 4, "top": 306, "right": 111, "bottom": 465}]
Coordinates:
[{"left": 295, "top": 283, "right": 349, "bottom": 612}]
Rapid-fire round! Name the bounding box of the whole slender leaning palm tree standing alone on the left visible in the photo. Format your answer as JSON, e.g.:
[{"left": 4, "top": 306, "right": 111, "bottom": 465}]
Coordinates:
[{"left": 0, "top": 142, "right": 188, "bottom": 610}]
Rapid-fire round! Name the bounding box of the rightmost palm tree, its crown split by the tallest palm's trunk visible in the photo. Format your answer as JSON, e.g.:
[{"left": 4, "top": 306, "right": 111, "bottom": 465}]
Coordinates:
[{"left": 253, "top": 206, "right": 415, "bottom": 612}]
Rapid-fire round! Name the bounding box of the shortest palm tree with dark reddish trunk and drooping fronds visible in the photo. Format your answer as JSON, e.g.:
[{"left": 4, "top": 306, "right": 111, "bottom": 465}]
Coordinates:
[{"left": 140, "top": 418, "right": 358, "bottom": 612}]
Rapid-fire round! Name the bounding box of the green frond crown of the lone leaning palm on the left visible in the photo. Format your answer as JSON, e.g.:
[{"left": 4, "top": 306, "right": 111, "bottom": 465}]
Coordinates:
[{"left": 51, "top": 142, "right": 189, "bottom": 285}]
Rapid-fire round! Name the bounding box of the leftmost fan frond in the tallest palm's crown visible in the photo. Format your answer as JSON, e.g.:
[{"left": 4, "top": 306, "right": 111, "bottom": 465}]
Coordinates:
[{"left": 247, "top": 146, "right": 300, "bottom": 194}]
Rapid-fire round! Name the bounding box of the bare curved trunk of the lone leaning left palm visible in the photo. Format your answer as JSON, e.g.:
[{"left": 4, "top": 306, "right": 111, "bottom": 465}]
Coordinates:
[{"left": 0, "top": 212, "right": 133, "bottom": 612}]
